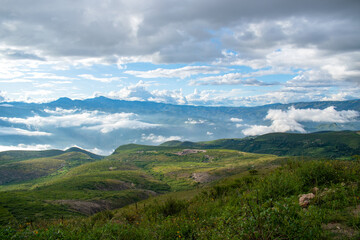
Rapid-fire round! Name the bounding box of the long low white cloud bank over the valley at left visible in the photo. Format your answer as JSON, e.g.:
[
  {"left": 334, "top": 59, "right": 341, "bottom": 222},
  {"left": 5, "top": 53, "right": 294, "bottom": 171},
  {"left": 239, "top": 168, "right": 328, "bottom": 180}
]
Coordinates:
[{"left": 0, "top": 109, "right": 161, "bottom": 134}]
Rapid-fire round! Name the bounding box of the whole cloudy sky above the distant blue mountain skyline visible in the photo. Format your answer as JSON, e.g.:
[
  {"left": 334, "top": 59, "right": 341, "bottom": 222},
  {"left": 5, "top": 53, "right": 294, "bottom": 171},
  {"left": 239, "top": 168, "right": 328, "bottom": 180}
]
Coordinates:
[{"left": 0, "top": 0, "right": 360, "bottom": 106}]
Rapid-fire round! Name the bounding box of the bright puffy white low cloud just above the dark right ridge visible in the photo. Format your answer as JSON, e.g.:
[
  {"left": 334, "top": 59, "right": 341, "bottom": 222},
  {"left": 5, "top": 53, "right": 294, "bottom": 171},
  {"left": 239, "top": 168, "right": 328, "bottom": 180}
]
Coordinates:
[{"left": 242, "top": 106, "right": 359, "bottom": 135}]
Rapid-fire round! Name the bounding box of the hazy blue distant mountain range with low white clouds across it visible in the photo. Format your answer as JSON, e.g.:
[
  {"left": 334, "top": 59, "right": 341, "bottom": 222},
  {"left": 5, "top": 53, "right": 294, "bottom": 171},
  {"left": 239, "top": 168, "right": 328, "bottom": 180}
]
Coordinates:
[{"left": 0, "top": 97, "right": 360, "bottom": 154}]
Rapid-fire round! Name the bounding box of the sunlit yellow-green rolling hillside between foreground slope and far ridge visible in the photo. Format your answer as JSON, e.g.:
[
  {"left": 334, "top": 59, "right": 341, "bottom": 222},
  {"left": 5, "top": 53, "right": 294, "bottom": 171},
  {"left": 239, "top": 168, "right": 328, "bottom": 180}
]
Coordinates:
[{"left": 0, "top": 145, "right": 282, "bottom": 225}]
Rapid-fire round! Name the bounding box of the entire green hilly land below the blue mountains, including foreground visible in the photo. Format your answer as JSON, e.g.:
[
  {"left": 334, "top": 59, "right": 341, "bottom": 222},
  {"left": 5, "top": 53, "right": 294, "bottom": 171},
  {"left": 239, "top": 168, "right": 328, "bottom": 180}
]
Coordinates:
[{"left": 0, "top": 132, "right": 360, "bottom": 239}]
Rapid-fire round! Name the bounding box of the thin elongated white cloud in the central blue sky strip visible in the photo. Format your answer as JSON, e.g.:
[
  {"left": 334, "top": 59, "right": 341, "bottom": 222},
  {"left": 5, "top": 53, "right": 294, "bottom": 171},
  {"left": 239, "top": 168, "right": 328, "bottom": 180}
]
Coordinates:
[{"left": 125, "top": 66, "right": 225, "bottom": 79}]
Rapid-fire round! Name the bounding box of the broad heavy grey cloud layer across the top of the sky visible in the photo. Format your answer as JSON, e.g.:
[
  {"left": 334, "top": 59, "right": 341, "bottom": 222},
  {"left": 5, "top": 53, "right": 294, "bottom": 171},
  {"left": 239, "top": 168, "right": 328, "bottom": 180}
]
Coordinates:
[{"left": 0, "top": 0, "right": 359, "bottom": 63}]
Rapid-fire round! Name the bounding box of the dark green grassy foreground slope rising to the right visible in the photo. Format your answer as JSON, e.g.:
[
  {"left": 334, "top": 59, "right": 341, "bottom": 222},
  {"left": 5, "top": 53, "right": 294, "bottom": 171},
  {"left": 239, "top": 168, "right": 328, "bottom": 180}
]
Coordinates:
[{"left": 0, "top": 158, "right": 360, "bottom": 239}]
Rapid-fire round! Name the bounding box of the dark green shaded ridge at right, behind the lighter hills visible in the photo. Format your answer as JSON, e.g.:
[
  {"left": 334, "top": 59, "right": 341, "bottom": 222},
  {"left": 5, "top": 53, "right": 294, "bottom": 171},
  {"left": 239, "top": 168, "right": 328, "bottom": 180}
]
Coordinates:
[{"left": 161, "top": 131, "right": 360, "bottom": 158}]
